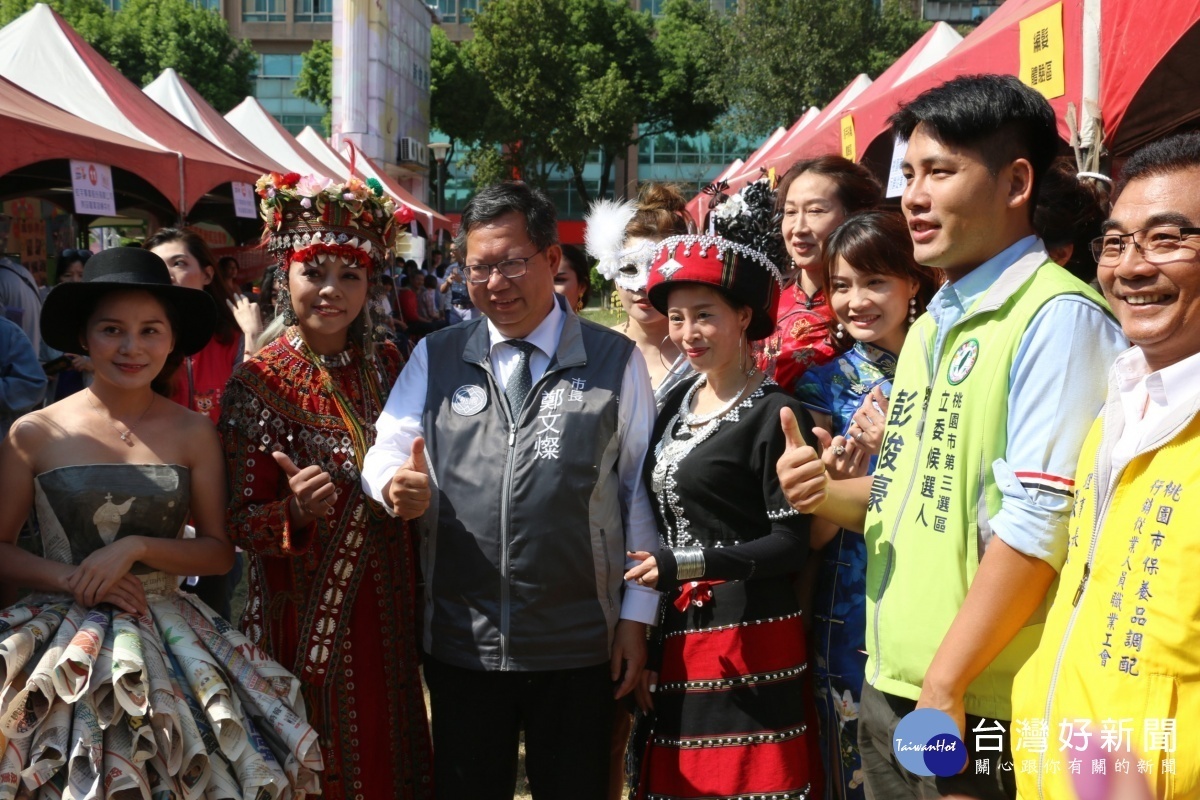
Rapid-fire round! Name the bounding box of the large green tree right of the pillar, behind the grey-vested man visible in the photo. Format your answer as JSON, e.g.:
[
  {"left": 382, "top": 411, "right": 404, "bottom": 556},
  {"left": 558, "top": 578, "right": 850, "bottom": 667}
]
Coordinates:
[{"left": 431, "top": 0, "right": 722, "bottom": 203}]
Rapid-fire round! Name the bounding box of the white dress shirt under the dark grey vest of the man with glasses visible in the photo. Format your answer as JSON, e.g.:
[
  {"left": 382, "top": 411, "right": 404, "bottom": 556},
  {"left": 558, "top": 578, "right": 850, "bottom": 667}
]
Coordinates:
[{"left": 362, "top": 301, "right": 659, "bottom": 625}]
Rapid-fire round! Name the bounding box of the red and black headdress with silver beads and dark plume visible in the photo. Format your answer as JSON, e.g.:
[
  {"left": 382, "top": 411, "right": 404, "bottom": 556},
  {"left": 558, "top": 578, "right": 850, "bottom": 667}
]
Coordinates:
[{"left": 648, "top": 179, "right": 785, "bottom": 339}]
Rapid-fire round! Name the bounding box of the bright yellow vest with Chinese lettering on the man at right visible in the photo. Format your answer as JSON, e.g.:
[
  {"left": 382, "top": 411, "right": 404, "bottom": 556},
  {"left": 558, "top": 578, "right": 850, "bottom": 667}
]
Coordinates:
[{"left": 1012, "top": 391, "right": 1200, "bottom": 800}]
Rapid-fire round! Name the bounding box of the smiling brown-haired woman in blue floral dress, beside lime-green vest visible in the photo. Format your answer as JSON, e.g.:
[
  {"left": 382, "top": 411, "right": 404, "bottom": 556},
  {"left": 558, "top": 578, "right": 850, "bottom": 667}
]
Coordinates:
[{"left": 796, "top": 211, "right": 940, "bottom": 800}]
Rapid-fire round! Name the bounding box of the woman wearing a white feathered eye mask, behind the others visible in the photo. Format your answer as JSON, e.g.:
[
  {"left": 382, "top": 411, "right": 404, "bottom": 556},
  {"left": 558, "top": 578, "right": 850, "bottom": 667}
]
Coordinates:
[{"left": 584, "top": 184, "right": 695, "bottom": 408}]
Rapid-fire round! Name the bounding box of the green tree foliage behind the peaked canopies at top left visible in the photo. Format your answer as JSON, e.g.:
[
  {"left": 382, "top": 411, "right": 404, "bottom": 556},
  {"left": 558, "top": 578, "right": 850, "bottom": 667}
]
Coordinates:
[{"left": 0, "top": 0, "right": 257, "bottom": 113}]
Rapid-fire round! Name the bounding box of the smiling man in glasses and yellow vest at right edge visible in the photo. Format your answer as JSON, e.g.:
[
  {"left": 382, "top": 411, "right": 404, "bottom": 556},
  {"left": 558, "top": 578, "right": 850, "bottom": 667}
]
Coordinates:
[{"left": 1013, "top": 133, "right": 1200, "bottom": 800}]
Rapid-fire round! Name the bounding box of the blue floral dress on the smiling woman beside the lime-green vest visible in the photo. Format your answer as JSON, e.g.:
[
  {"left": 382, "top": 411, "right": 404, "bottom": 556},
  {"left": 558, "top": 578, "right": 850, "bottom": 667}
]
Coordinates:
[{"left": 796, "top": 342, "right": 896, "bottom": 800}]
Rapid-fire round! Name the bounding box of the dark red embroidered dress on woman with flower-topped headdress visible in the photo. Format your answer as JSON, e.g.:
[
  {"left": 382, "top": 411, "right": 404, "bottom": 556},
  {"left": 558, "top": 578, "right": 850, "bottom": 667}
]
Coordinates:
[{"left": 220, "top": 329, "right": 433, "bottom": 800}]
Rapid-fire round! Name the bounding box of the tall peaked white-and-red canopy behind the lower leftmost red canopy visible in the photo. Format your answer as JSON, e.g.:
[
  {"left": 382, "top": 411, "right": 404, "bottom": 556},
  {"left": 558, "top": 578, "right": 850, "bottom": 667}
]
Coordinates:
[{"left": 0, "top": 4, "right": 258, "bottom": 213}]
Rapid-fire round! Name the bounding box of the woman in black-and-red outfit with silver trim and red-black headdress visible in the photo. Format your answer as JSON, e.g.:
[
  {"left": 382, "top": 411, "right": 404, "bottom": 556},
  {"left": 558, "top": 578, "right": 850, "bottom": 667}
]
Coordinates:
[{"left": 625, "top": 179, "right": 822, "bottom": 800}]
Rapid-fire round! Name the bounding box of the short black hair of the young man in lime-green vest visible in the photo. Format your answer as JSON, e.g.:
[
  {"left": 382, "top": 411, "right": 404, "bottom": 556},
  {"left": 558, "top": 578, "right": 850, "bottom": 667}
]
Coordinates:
[{"left": 888, "top": 74, "right": 1058, "bottom": 206}]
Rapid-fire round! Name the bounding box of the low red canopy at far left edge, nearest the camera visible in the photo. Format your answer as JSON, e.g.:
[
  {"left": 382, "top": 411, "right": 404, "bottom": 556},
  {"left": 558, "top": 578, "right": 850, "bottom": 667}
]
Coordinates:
[{"left": 0, "top": 72, "right": 179, "bottom": 212}]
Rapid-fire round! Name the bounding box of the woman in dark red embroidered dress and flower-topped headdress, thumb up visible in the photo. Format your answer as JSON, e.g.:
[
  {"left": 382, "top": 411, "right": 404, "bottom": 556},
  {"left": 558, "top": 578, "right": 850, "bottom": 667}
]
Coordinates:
[{"left": 220, "top": 174, "right": 433, "bottom": 800}]
